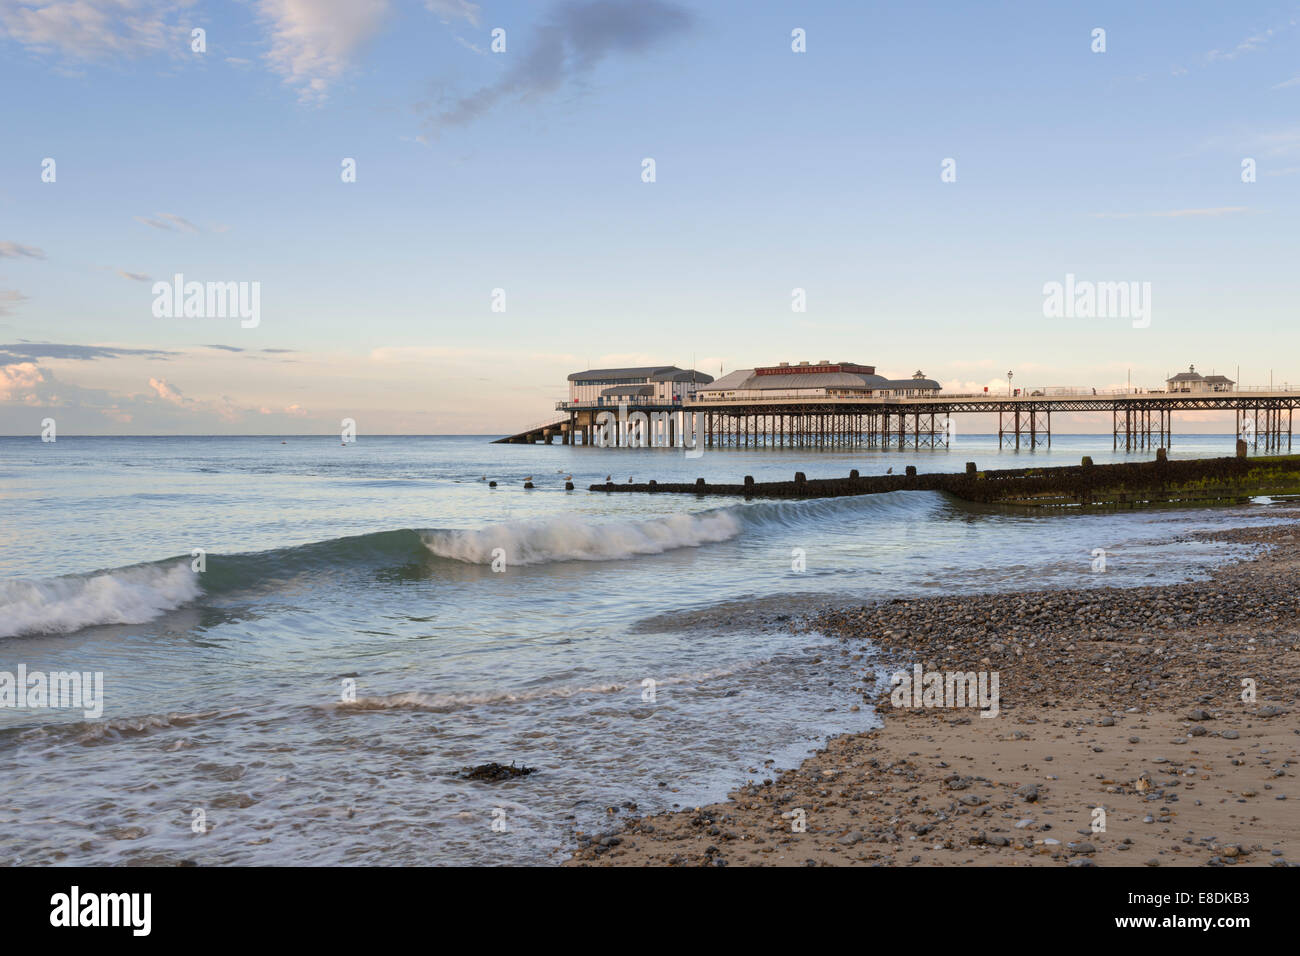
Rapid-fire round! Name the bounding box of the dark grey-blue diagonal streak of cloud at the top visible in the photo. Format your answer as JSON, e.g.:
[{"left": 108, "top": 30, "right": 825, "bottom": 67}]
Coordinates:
[{"left": 428, "top": 0, "right": 693, "bottom": 130}]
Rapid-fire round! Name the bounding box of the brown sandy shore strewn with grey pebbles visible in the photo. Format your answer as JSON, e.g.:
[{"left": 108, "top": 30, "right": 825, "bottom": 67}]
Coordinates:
[{"left": 567, "top": 510, "right": 1300, "bottom": 866}]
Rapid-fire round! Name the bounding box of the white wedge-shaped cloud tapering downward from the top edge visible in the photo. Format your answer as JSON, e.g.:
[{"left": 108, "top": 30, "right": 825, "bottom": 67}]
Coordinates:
[{"left": 257, "top": 0, "right": 391, "bottom": 103}]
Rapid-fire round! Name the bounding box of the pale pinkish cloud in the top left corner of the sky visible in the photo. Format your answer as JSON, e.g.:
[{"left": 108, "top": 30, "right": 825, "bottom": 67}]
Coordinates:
[{"left": 0, "top": 0, "right": 190, "bottom": 60}]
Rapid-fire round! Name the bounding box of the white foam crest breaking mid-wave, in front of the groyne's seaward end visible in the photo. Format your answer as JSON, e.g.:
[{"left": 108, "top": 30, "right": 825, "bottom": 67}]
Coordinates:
[{"left": 421, "top": 511, "right": 741, "bottom": 566}]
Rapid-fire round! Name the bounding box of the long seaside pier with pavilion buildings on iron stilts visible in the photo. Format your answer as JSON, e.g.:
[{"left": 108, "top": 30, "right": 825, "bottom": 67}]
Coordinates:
[{"left": 498, "top": 359, "right": 1300, "bottom": 454}]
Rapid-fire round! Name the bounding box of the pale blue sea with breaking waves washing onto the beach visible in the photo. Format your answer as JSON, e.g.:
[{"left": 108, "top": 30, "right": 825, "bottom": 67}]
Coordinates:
[{"left": 0, "top": 434, "right": 1277, "bottom": 865}]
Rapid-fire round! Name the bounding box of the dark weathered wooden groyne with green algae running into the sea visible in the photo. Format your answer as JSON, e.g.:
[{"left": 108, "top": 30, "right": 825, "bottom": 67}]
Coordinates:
[{"left": 590, "top": 442, "right": 1300, "bottom": 509}]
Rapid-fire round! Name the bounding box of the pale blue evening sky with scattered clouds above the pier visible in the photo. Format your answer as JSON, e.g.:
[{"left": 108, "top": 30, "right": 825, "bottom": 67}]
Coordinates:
[{"left": 0, "top": 0, "right": 1300, "bottom": 436}]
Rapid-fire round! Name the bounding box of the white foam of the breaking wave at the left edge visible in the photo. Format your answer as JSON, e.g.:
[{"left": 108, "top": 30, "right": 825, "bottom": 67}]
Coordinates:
[{"left": 0, "top": 559, "right": 202, "bottom": 637}]
